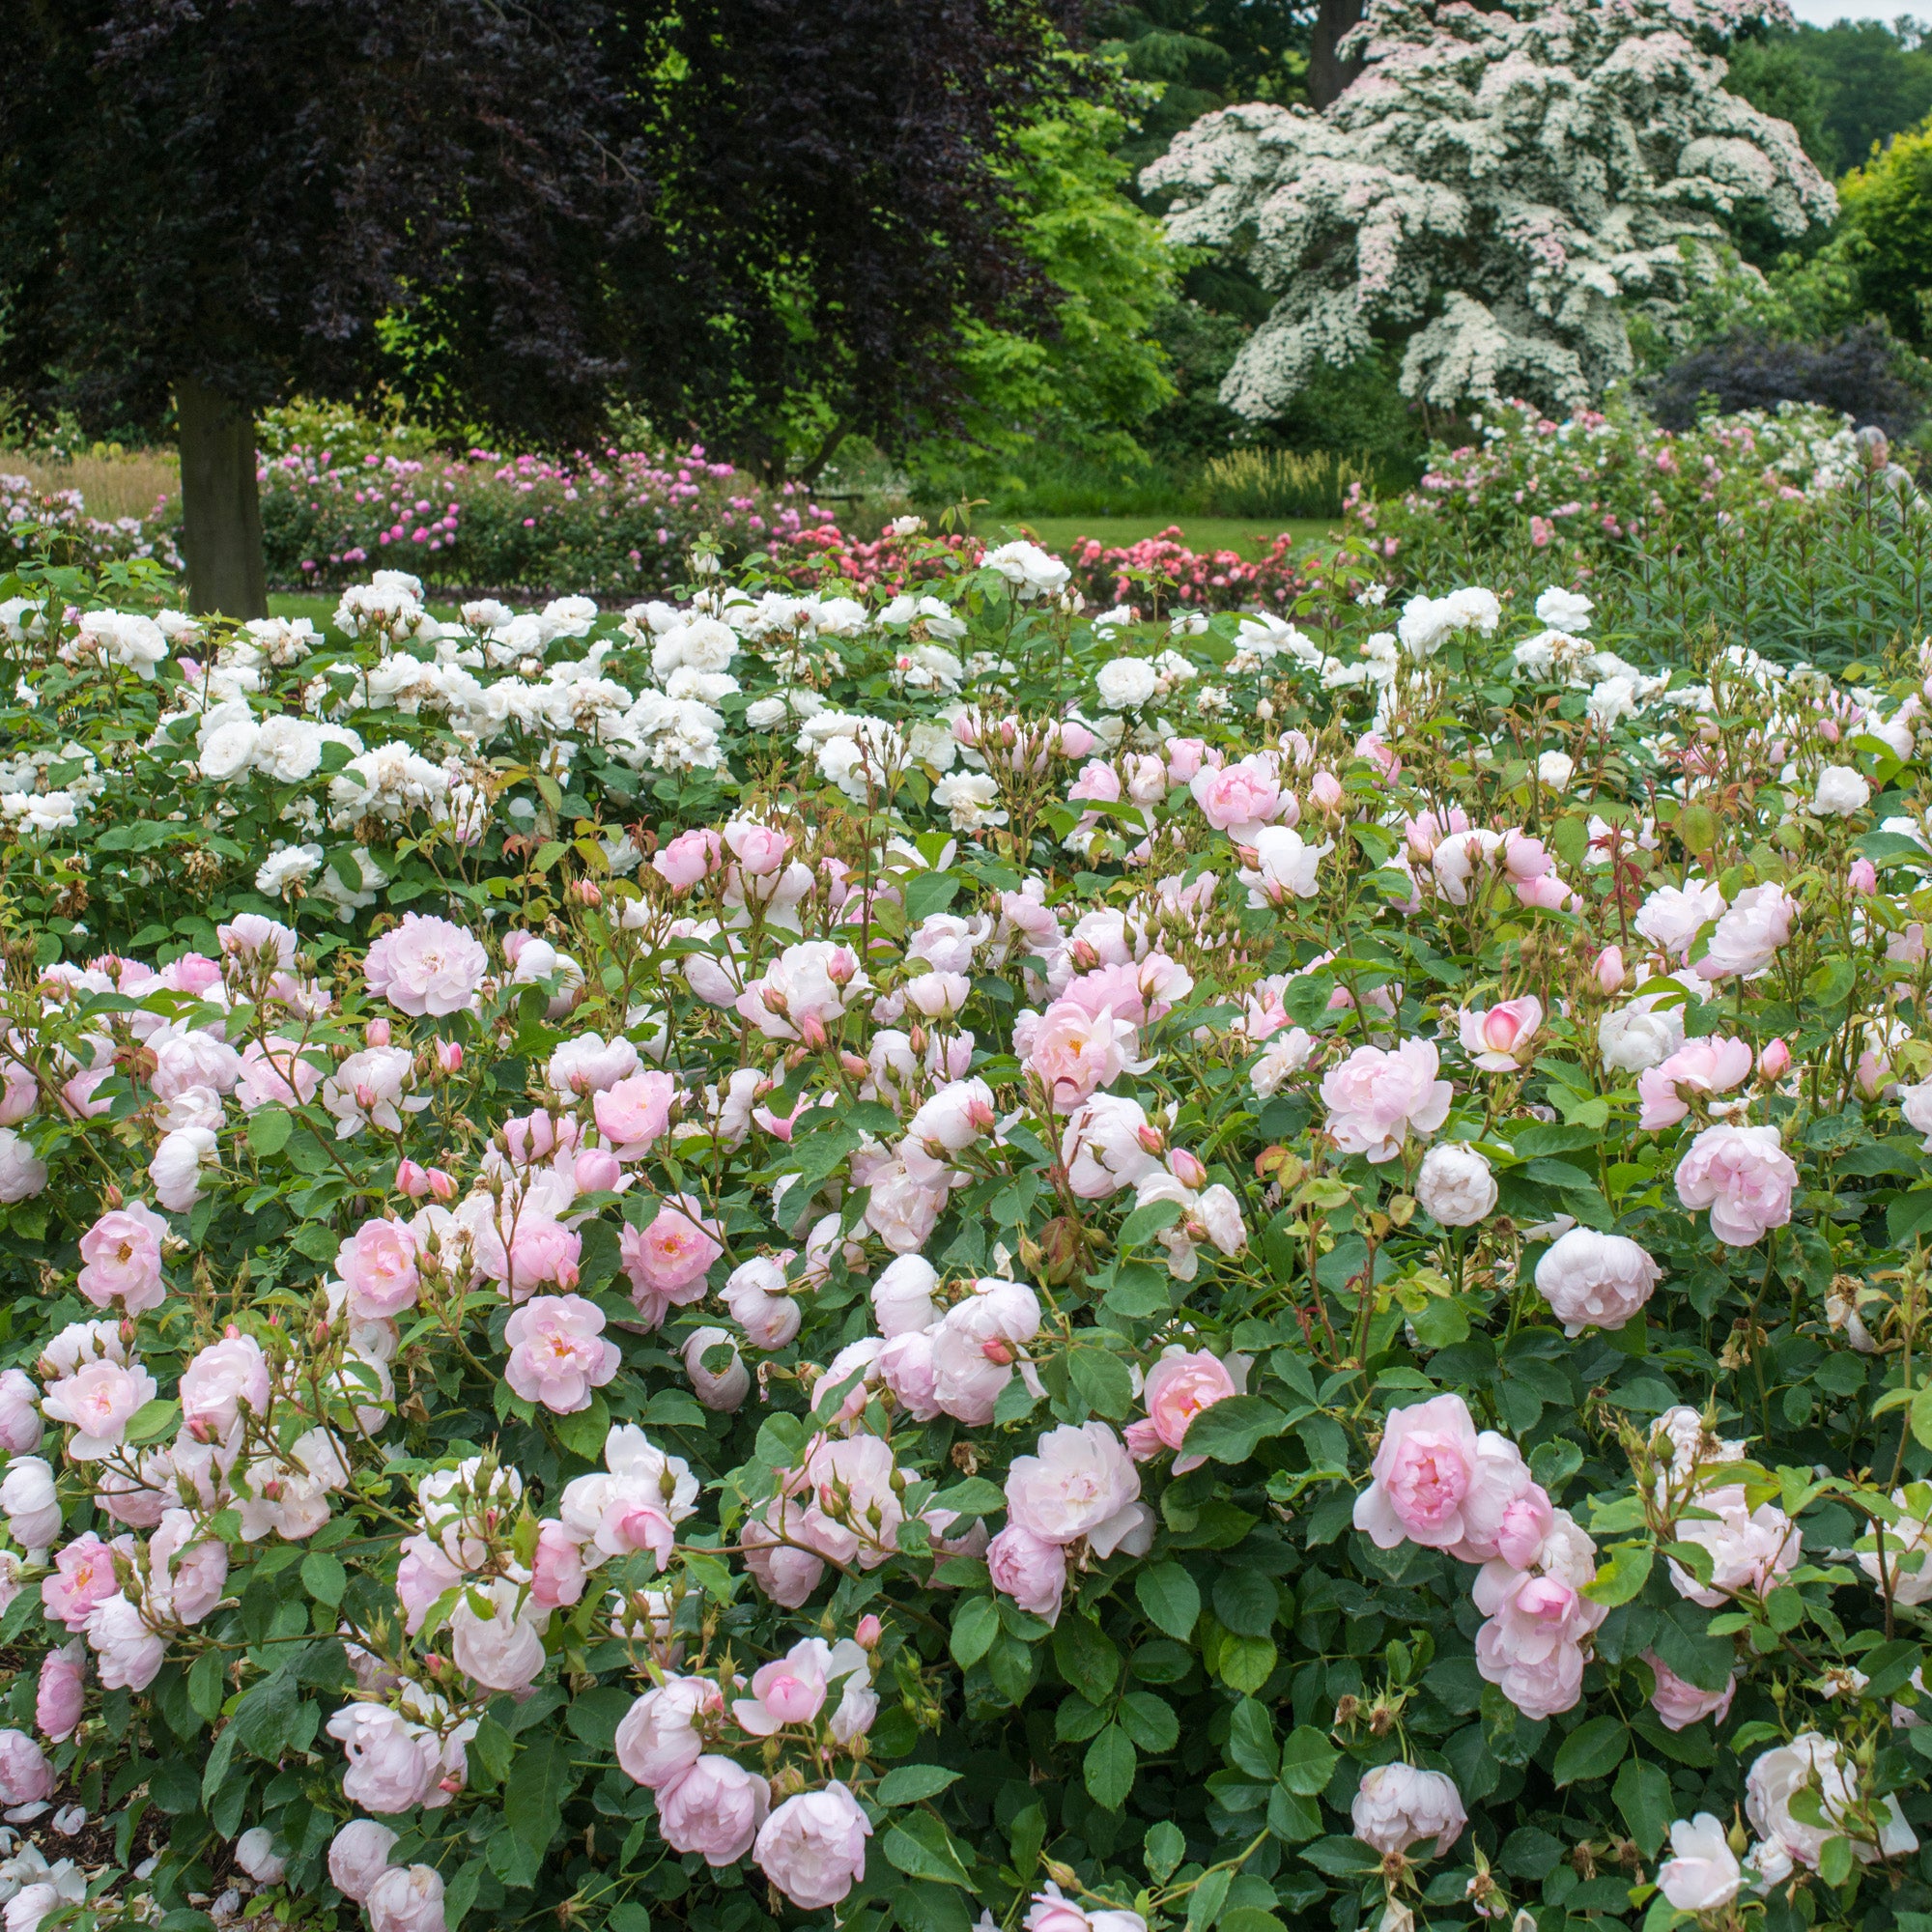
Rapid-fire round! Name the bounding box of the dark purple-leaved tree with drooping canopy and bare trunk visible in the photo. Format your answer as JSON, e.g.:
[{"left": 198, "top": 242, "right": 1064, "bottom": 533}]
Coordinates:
[{"left": 0, "top": 0, "right": 1061, "bottom": 616}]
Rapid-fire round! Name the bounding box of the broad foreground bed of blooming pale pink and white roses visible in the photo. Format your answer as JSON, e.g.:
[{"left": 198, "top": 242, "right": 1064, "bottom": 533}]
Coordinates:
[{"left": 0, "top": 533, "right": 1932, "bottom": 1932}]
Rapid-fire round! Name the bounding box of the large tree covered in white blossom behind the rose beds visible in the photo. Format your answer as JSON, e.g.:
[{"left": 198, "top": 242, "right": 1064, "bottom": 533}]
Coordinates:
[{"left": 1142, "top": 0, "right": 1835, "bottom": 417}]
